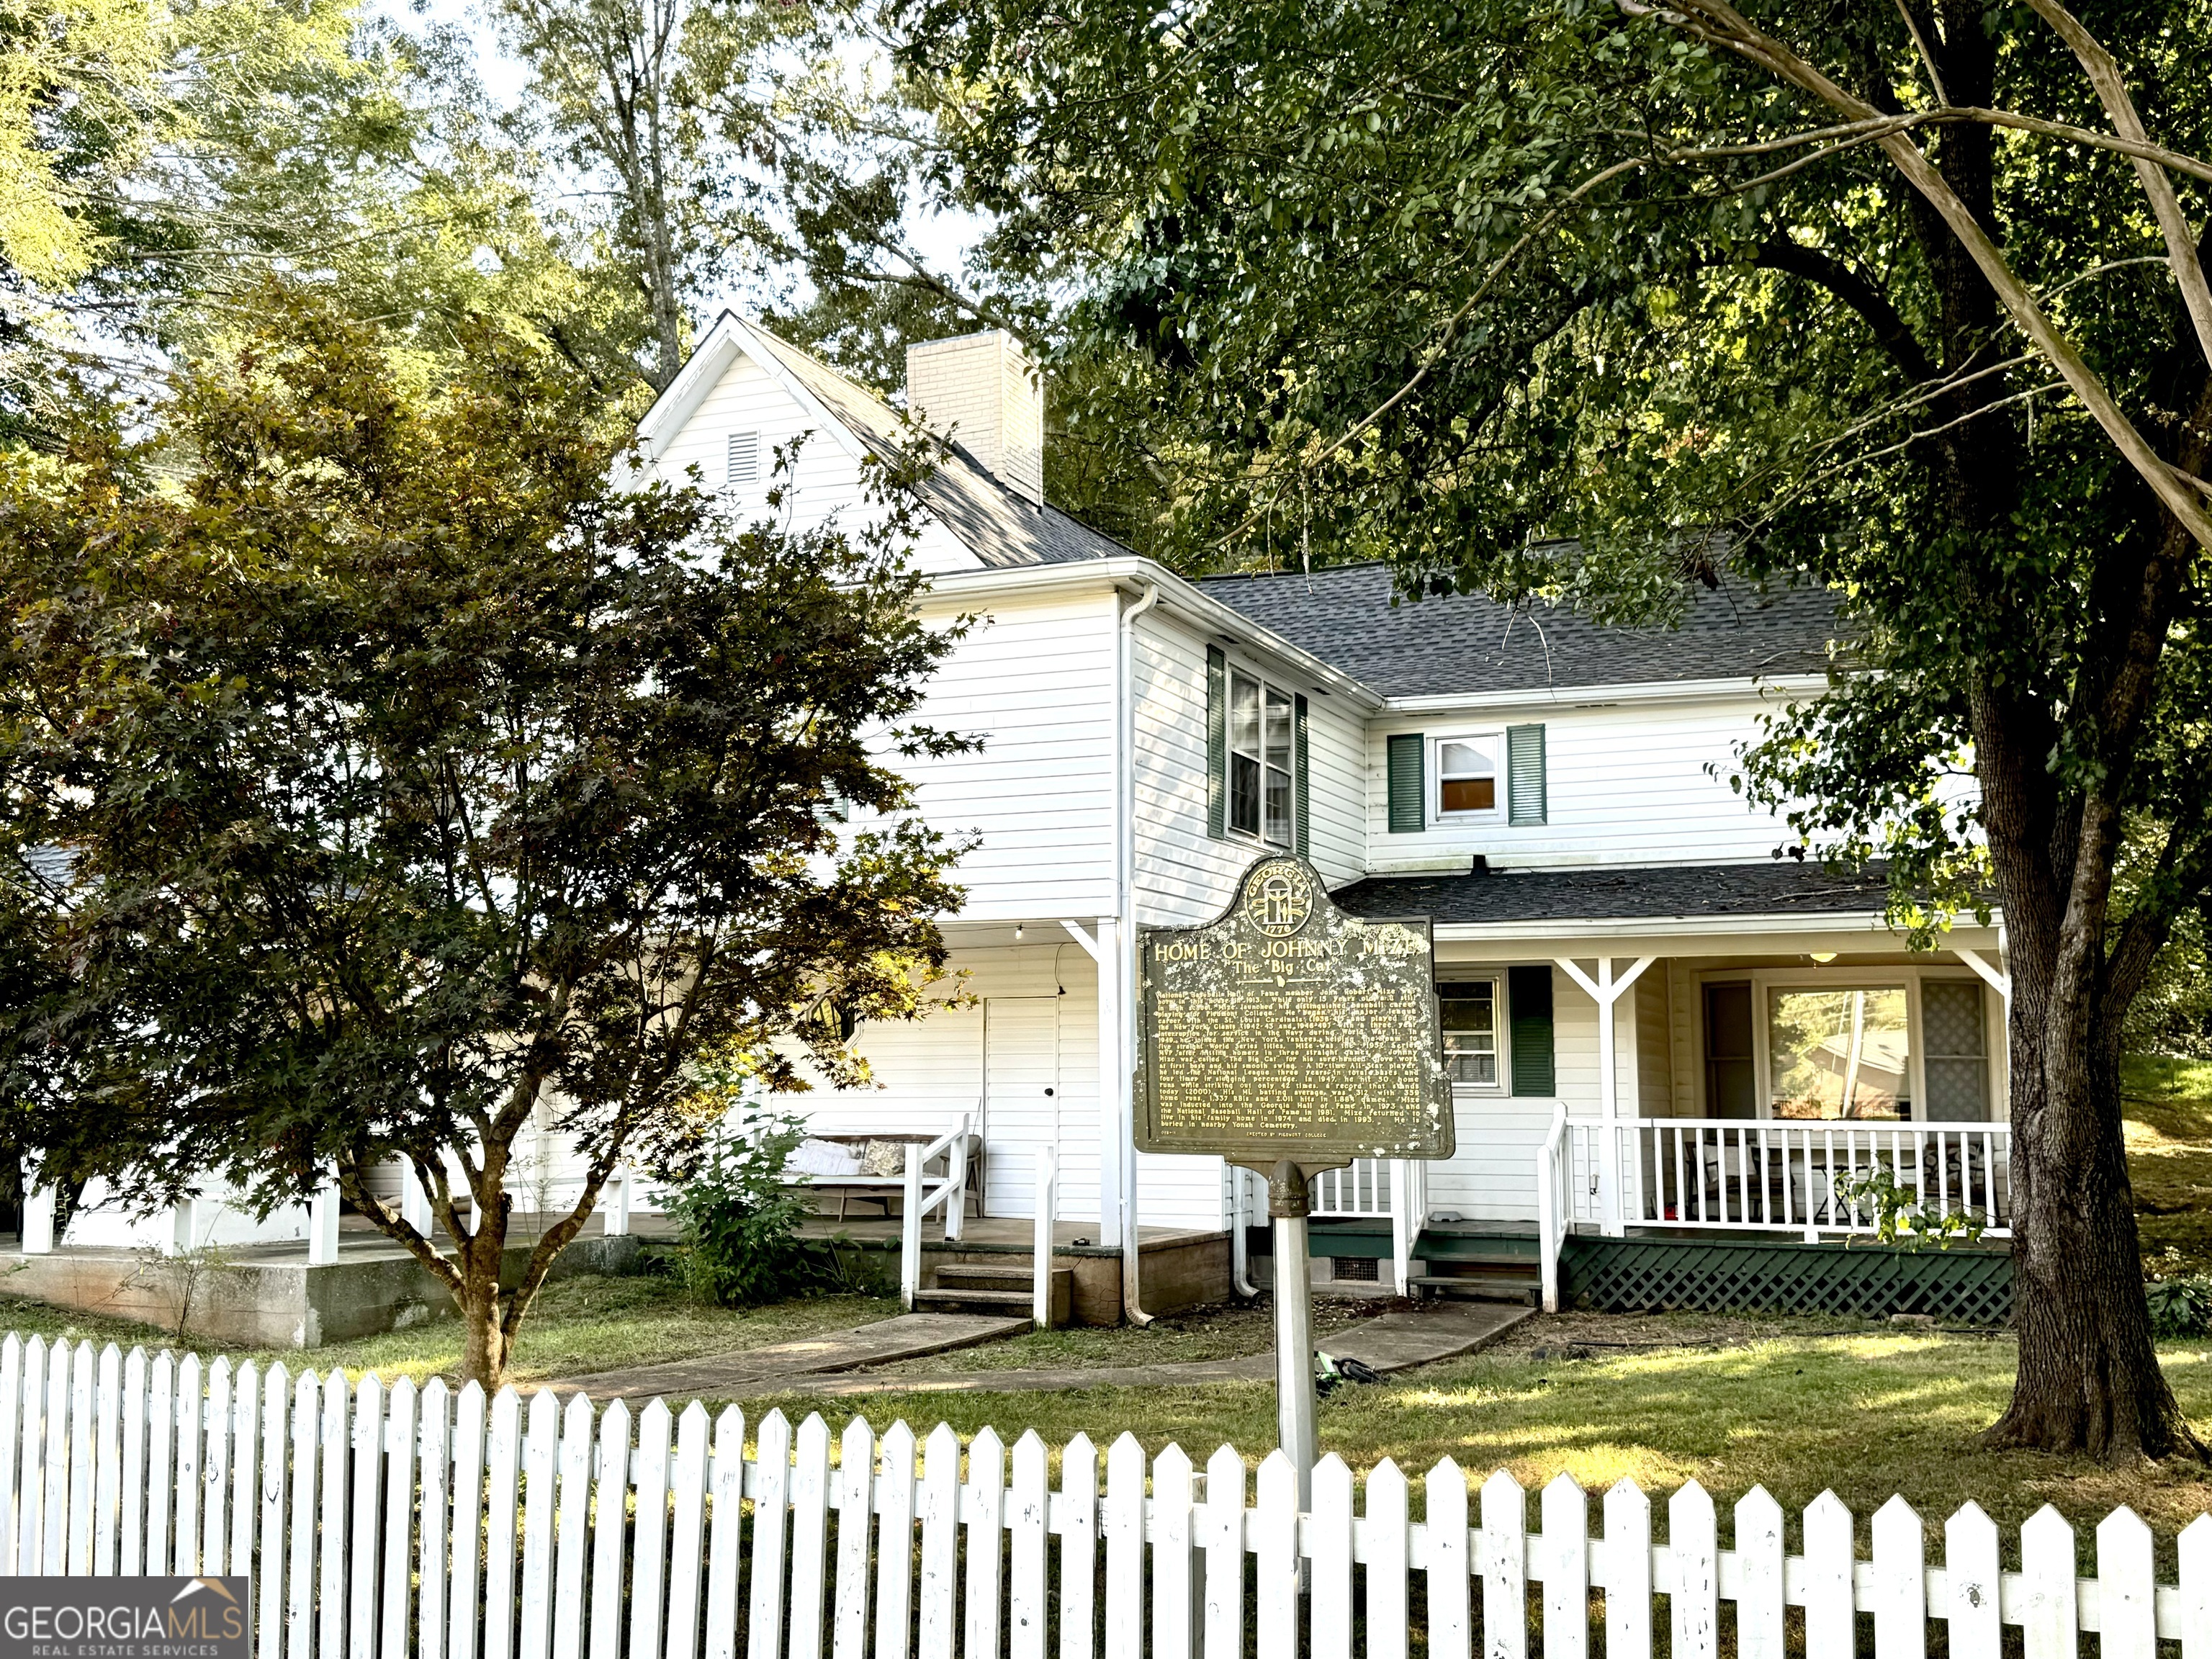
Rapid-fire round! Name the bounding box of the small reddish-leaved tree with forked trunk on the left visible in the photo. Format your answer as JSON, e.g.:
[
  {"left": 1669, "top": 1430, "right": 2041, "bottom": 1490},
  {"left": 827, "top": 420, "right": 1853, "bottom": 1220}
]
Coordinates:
[{"left": 0, "top": 287, "right": 958, "bottom": 1382}]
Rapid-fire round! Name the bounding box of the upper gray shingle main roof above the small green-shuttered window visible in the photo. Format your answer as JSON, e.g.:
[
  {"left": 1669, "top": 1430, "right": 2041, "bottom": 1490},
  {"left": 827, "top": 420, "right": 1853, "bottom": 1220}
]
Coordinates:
[{"left": 1203, "top": 564, "right": 1838, "bottom": 697}]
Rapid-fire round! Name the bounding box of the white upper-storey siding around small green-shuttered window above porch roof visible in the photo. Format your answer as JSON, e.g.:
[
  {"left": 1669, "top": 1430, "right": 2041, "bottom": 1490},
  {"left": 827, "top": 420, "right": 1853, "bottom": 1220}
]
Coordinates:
[{"left": 1367, "top": 690, "right": 1785, "bottom": 869}]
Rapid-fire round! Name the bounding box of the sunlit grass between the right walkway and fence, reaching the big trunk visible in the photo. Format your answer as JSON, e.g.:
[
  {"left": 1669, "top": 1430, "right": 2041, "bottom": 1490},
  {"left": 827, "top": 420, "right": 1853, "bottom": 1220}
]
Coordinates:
[{"left": 745, "top": 1314, "right": 2212, "bottom": 1560}]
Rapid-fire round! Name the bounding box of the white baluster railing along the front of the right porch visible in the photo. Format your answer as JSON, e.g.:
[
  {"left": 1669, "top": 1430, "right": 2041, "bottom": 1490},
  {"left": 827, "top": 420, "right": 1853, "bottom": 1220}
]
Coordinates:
[{"left": 1564, "top": 1117, "right": 2013, "bottom": 1241}]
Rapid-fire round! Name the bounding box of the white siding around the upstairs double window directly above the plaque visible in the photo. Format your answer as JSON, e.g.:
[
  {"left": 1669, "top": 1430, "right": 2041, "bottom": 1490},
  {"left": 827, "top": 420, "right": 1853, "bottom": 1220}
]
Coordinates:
[{"left": 1133, "top": 613, "right": 1364, "bottom": 927}]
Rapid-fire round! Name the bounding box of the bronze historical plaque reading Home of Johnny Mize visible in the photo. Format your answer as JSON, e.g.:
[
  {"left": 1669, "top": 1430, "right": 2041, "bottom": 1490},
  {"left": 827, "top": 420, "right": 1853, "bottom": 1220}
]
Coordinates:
[{"left": 1137, "top": 856, "right": 1453, "bottom": 1170}]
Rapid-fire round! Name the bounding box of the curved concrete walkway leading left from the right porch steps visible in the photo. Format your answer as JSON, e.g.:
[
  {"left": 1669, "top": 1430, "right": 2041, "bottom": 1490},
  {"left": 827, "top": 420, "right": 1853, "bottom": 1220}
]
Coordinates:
[{"left": 698, "top": 1303, "right": 1535, "bottom": 1401}]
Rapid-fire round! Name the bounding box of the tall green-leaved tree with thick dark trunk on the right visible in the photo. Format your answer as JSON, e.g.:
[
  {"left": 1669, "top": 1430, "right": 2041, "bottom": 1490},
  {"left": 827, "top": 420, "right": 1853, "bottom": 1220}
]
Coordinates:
[{"left": 907, "top": 0, "right": 2212, "bottom": 1457}]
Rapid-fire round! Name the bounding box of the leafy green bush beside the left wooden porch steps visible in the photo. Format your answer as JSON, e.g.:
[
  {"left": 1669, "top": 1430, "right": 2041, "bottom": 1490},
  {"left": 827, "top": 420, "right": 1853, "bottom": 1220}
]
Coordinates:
[{"left": 670, "top": 1112, "right": 809, "bottom": 1308}]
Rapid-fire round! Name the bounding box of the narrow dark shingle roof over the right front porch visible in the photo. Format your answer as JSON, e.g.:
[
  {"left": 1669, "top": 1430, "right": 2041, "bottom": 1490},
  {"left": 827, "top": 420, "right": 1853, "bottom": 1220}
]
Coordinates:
[{"left": 1329, "top": 858, "right": 1889, "bottom": 922}]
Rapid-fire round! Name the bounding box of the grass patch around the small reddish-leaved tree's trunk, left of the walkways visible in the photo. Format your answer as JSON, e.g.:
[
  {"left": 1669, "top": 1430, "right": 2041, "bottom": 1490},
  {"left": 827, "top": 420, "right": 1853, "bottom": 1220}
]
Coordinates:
[{"left": 0, "top": 1277, "right": 898, "bottom": 1382}]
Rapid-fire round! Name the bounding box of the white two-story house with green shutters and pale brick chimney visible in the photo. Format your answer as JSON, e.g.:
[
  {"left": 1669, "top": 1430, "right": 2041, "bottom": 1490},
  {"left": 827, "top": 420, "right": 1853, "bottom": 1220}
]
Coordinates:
[{"left": 639, "top": 314, "right": 2006, "bottom": 1308}]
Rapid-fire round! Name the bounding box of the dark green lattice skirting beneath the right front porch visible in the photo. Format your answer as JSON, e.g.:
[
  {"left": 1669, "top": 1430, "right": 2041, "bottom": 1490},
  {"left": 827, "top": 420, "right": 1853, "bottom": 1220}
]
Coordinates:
[{"left": 1560, "top": 1234, "right": 2013, "bottom": 1325}]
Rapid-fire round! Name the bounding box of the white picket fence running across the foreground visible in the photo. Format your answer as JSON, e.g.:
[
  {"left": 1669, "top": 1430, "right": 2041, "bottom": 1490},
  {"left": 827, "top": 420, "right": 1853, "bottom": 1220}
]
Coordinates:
[{"left": 0, "top": 1336, "right": 2212, "bottom": 1659}]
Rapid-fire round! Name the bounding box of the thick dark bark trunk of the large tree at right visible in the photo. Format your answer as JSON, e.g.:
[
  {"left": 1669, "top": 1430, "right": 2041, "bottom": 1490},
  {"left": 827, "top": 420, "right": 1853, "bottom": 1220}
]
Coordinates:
[{"left": 1984, "top": 997, "right": 2203, "bottom": 1462}]
